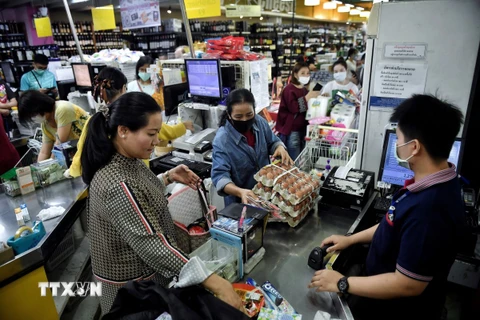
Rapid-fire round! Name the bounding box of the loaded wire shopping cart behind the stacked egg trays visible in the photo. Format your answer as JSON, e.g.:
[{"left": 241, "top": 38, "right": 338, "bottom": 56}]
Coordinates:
[{"left": 295, "top": 125, "right": 358, "bottom": 173}]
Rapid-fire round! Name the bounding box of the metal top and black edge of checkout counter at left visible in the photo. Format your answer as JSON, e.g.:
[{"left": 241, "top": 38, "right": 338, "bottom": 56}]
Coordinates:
[{"left": 0, "top": 178, "right": 86, "bottom": 287}]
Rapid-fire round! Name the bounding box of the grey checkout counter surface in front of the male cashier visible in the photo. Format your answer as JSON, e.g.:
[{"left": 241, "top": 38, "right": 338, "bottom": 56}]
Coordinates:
[{"left": 245, "top": 205, "right": 360, "bottom": 320}]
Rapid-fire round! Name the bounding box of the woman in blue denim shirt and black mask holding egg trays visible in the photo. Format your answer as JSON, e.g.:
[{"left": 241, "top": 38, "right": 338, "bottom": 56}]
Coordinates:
[{"left": 212, "top": 89, "right": 293, "bottom": 206}]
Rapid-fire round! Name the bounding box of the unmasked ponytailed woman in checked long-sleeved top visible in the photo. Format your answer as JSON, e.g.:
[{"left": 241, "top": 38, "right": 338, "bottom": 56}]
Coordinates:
[{"left": 82, "top": 92, "right": 242, "bottom": 313}]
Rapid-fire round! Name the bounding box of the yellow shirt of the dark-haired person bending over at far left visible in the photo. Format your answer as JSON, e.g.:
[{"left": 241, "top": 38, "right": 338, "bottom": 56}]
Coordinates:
[{"left": 42, "top": 101, "right": 89, "bottom": 143}]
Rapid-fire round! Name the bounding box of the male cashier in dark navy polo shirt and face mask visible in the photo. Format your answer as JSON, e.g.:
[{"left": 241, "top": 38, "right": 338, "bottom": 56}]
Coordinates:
[{"left": 310, "top": 95, "right": 466, "bottom": 320}]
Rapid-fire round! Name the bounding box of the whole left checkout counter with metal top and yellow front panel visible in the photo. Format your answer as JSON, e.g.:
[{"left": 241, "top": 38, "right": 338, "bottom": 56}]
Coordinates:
[{"left": 0, "top": 178, "right": 88, "bottom": 319}]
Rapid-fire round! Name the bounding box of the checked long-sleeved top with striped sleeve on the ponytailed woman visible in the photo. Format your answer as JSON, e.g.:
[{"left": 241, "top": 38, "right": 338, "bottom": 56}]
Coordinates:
[{"left": 87, "top": 153, "right": 211, "bottom": 313}]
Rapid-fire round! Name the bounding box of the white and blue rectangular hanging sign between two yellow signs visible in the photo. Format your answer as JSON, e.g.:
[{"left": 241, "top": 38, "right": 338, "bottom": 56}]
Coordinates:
[{"left": 120, "top": 0, "right": 161, "bottom": 29}]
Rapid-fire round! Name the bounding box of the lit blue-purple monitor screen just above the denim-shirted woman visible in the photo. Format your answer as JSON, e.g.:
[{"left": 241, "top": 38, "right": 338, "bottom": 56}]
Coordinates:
[{"left": 185, "top": 59, "right": 222, "bottom": 99}]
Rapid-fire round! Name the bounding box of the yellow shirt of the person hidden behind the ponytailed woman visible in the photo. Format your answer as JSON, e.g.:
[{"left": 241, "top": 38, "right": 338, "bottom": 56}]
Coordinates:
[{"left": 70, "top": 120, "right": 187, "bottom": 178}]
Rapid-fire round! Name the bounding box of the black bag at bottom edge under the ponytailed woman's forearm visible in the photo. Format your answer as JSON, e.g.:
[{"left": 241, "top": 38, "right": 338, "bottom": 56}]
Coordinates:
[{"left": 102, "top": 280, "right": 249, "bottom": 320}]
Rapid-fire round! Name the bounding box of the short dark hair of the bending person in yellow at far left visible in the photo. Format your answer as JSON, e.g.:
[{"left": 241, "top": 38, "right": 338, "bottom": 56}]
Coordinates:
[{"left": 18, "top": 90, "right": 55, "bottom": 126}]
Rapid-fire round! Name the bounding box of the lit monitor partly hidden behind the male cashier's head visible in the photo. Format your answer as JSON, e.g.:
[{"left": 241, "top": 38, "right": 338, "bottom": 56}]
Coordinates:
[{"left": 379, "top": 130, "right": 462, "bottom": 187}]
